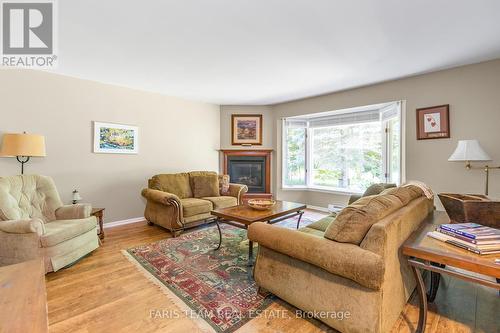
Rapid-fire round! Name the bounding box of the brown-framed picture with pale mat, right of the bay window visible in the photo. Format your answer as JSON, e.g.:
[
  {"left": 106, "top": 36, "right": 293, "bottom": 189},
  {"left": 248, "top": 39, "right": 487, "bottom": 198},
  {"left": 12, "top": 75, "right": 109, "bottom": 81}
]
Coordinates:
[{"left": 417, "top": 104, "right": 450, "bottom": 140}]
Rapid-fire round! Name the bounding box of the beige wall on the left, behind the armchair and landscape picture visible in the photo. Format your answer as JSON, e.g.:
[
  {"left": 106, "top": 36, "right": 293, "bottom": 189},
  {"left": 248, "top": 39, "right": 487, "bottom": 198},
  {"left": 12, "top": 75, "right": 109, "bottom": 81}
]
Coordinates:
[{"left": 0, "top": 70, "right": 220, "bottom": 222}]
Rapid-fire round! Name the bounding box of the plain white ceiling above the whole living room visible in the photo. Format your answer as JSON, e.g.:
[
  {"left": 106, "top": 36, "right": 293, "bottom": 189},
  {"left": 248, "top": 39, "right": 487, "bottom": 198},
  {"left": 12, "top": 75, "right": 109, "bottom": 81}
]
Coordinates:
[{"left": 54, "top": 0, "right": 500, "bottom": 104}]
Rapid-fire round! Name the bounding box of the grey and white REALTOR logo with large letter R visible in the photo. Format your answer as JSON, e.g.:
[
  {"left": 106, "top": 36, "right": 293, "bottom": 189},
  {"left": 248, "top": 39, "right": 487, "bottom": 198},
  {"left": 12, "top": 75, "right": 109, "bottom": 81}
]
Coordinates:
[{"left": 1, "top": 1, "right": 57, "bottom": 68}]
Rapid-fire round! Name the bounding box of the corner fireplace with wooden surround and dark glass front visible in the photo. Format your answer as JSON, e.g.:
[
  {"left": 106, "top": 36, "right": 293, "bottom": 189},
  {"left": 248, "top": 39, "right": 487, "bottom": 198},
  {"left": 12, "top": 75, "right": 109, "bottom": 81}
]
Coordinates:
[{"left": 222, "top": 149, "right": 272, "bottom": 200}]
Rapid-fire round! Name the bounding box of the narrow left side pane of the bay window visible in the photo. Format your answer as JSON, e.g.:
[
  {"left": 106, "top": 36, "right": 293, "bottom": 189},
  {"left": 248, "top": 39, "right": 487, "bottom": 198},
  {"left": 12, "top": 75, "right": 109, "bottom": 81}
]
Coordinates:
[{"left": 284, "top": 127, "right": 306, "bottom": 186}]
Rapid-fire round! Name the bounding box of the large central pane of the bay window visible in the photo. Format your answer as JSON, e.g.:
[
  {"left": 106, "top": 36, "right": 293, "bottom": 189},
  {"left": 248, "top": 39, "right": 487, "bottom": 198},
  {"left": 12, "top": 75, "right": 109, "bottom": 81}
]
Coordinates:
[{"left": 311, "top": 122, "right": 382, "bottom": 192}]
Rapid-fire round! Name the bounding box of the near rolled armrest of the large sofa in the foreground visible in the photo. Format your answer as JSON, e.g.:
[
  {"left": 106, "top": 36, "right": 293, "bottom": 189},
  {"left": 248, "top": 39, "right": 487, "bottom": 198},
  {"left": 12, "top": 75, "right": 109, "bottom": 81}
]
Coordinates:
[{"left": 248, "top": 222, "right": 385, "bottom": 290}]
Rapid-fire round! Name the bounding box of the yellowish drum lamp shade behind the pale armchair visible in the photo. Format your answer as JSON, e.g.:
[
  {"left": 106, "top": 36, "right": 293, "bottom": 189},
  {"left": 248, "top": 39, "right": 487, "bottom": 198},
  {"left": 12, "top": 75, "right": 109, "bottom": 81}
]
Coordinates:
[{"left": 0, "top": 133, "right": 46, "bottom": 157}]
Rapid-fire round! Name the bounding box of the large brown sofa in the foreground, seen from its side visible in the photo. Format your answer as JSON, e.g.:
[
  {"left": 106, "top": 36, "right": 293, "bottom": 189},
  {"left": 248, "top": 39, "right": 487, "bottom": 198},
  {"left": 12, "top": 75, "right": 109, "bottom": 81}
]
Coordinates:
[{"left": 248, "top": 186, "right": 433, "bottom": 333}]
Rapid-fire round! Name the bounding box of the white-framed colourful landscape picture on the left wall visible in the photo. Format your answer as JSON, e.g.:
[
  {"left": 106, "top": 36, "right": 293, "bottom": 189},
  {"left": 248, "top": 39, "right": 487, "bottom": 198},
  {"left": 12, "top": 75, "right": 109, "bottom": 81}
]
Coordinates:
[{"left": 94, "top": 121, "right": 139, "bottom": 154}]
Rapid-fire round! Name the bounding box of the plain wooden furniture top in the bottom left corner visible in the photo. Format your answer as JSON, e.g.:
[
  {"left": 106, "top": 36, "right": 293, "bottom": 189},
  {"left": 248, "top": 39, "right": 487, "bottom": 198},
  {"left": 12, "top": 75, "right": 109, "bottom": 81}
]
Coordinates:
[{"left": 0, "top": 259, "right": 49, "bottom": 333}]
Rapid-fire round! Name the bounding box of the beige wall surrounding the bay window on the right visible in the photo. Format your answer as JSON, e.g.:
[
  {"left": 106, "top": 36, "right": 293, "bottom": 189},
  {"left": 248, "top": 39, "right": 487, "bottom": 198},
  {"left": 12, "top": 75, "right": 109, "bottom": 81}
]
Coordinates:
[{"left": 272, "top": 60, "right": 500, "bottom": 207}]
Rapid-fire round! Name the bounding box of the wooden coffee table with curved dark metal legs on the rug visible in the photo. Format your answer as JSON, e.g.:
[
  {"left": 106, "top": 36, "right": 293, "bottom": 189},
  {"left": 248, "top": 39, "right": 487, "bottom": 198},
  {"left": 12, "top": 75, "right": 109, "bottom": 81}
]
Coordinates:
[{"left": 212, "top": 201, "right": 306, "bottom": 264}]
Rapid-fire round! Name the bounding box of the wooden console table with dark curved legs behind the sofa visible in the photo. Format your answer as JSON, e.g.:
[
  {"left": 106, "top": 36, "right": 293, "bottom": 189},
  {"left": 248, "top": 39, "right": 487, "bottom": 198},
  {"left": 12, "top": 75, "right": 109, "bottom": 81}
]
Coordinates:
[{"left": 403, "top": 211, "right": 500, "bottom": 333}]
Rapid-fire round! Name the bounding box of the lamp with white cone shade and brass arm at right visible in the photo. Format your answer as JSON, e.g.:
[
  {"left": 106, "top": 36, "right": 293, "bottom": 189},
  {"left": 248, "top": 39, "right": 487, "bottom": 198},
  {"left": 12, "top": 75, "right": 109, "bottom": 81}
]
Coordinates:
[{"left": 448, "top": 140, "right": 500, "bottom": 195}]
